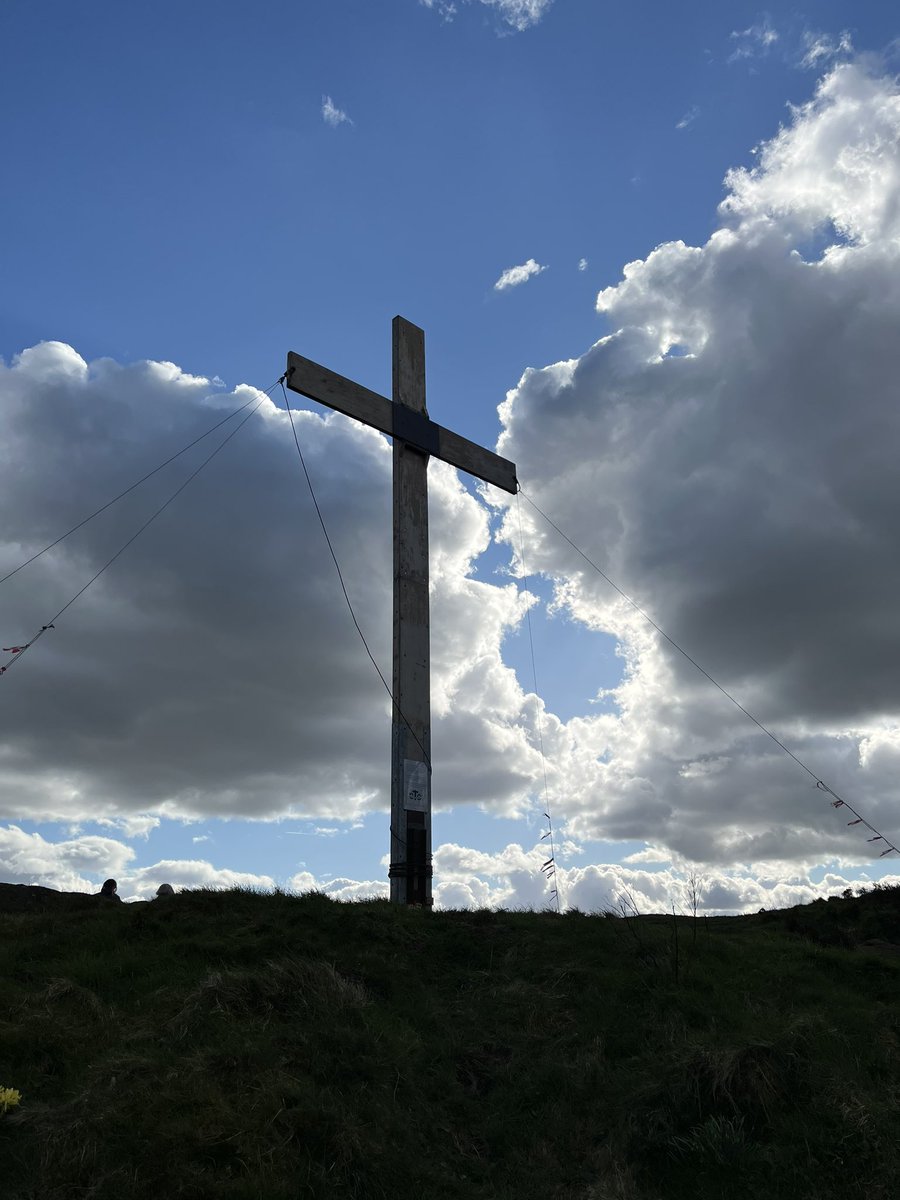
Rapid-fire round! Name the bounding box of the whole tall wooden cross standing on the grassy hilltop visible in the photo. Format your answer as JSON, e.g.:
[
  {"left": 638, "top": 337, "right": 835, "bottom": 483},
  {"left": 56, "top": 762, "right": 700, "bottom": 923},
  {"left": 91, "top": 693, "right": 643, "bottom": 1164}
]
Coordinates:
[{"left": 287, "top": 317, "right": 518, "bottom": 906}]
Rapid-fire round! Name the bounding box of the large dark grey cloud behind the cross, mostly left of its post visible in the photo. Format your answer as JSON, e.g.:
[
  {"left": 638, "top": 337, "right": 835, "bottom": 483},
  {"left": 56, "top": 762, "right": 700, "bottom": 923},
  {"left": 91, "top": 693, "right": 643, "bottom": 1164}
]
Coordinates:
[{"left": 0, "top": 343, "right": 542, "bottom": 820}]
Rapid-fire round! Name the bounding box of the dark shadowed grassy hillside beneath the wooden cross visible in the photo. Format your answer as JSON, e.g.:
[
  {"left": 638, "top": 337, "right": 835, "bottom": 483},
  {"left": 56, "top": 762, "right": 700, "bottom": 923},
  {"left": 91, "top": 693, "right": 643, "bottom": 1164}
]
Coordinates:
[{"left": 0, "top": 886, "right": 900, "bottom": 1200}]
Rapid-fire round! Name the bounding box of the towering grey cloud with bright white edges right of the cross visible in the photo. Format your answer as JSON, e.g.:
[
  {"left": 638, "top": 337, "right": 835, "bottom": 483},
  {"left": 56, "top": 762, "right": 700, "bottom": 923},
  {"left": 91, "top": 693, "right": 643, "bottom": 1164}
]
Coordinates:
[{"left": 500, "top": 64, "right": 900, "bottom": 874}]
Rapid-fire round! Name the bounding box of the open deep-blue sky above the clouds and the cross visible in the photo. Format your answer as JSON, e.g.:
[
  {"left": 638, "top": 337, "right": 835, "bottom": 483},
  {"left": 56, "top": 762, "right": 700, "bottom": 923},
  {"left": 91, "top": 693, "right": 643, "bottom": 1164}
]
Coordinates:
[{"left": 0, "top": 0, "right": 883, "bottom": 403}]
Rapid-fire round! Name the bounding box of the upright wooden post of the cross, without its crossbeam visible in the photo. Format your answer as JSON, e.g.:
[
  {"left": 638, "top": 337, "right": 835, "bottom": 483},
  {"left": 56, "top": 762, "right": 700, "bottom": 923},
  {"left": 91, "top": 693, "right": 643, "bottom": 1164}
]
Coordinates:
[{"left": 389, "top": 317, "right": 432, "bottom": 907}]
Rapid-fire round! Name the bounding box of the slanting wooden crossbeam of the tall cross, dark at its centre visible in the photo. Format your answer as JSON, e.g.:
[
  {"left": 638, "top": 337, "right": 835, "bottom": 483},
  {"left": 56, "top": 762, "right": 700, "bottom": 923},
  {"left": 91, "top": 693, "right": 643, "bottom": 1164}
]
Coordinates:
[{"left": 284, "top": 350, "right": 518, "bottom": 494}]
